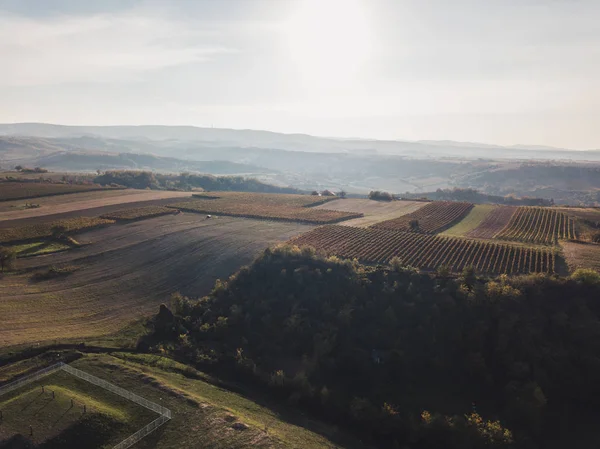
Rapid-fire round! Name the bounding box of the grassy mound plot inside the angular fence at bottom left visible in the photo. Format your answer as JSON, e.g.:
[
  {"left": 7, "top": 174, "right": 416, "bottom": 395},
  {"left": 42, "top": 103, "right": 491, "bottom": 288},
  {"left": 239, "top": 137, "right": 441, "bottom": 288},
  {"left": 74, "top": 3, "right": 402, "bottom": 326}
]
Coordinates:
[{"left": 0, "top": 371, "right": 158, "bottom": 448}]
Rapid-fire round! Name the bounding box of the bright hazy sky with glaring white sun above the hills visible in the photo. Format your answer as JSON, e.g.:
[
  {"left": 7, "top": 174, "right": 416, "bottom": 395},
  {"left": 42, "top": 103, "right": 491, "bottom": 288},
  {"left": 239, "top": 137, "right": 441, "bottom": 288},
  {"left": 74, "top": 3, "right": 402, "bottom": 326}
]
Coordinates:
[{"left": 0, "top": 0, "right": 600, "bottom": 149}]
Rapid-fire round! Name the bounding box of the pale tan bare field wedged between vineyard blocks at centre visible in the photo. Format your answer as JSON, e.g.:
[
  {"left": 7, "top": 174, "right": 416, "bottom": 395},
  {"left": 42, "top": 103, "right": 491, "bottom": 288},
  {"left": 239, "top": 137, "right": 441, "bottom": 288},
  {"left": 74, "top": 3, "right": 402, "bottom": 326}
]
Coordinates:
[{"left": 314, "top": 198, "right": 427, "bottom": 228}]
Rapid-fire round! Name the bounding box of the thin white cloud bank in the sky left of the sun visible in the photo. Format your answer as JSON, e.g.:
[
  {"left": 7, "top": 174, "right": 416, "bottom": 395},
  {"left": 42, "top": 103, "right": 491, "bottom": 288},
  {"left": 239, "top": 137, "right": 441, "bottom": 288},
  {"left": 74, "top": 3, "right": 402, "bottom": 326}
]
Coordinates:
[{"left": 0, "top": 12, "right": 233, "bottom": 87}]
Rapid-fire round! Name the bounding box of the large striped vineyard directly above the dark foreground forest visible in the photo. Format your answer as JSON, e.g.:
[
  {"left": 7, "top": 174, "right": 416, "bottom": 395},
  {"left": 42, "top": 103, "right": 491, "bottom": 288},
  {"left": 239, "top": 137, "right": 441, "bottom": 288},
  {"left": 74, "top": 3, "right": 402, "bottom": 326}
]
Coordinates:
[{"left": 290, "top": 225, "right": 561, "bottom": 274}]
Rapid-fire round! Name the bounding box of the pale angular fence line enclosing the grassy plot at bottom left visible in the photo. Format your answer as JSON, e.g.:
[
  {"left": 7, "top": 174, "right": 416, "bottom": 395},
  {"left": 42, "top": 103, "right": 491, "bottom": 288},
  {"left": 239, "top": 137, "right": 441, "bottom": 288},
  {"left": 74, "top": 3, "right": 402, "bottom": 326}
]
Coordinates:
[{"left": 0, "top": 362, "right": 171, "bottom": 449}]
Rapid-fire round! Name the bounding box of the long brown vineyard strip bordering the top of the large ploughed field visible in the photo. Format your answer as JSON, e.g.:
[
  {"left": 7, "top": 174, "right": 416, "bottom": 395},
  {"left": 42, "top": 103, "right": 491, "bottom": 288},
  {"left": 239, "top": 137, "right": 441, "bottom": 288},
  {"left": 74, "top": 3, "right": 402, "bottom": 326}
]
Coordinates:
[{"left": 169, "top": 199, "right": 363, "bottom": 224}]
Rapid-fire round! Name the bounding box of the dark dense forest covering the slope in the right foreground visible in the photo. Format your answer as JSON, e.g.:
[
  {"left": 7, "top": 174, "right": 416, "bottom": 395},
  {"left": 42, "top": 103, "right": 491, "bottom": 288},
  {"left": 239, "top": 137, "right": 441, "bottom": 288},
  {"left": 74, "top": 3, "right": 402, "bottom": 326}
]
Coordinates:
[{"left": 139, "top": 246, "right": 600, "bottom": 449}]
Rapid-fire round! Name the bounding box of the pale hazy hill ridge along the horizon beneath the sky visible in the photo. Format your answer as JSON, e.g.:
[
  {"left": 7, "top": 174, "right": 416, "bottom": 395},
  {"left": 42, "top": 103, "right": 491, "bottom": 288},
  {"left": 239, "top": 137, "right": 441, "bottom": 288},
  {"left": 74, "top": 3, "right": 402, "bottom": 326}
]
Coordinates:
[{"left": 0, "top": 123, "right": 600, "bottom": 161}]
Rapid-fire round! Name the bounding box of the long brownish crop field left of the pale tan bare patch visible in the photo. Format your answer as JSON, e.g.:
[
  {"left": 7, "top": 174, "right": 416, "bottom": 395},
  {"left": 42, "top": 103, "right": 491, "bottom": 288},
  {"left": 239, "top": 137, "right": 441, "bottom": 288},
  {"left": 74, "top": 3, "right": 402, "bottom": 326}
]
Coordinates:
[{"left": 169, "top": 192, "right": 362, "bottom": 224}]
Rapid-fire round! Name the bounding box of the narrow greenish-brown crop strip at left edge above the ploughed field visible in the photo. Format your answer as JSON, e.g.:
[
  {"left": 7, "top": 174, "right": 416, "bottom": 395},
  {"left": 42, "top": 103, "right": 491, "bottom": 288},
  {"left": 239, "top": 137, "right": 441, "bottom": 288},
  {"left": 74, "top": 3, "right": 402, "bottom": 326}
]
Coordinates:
[{"left": 0, "top": 217, "right": 114, "bottom": 243}]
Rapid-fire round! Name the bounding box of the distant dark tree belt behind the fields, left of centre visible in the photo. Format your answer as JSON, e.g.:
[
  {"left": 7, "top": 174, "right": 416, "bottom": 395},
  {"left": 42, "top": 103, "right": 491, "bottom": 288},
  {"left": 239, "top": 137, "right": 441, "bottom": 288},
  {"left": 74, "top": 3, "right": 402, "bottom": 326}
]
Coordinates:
[{"left": 94, "top": 170, "right": 301, "bottom": 193}]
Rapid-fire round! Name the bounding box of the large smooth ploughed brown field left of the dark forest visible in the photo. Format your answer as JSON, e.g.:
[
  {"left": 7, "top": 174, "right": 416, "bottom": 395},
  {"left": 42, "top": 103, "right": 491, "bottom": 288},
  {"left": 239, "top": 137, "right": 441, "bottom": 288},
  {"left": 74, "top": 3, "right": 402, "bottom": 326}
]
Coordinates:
[{"left": 0, "top": 213, "right": 312, "bottom": 347}]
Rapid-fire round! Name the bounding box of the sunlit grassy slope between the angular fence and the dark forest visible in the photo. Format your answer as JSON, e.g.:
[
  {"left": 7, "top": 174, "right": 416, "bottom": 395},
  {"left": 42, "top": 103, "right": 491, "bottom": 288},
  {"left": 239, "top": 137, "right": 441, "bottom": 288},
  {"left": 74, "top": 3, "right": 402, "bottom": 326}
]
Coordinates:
[{"left": 0, "top": 353, "right": 363, "bottom": 449}]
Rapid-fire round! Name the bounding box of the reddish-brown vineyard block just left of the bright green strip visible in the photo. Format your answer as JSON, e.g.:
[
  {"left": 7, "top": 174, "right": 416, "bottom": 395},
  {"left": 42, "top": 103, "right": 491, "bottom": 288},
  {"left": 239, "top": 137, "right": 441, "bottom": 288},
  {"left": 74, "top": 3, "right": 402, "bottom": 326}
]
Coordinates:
[{"left": 372, "top": 201, "right": 473, "bottom": 234}]
